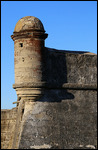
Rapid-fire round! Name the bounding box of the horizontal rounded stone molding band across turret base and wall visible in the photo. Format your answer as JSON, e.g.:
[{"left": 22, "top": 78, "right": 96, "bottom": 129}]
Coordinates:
[{"left": 13, "top": 82, "right": 97, "bottom": 90}]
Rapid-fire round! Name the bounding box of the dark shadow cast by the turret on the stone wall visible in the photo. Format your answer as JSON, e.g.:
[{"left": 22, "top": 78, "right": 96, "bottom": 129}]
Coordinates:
[{"left": 37, "top": 48, "right": 74, "bottom": 102}]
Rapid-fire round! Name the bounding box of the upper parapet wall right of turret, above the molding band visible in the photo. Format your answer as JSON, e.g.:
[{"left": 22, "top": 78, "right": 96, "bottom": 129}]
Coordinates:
[{"left": 42, "top": 48, "right": 97, "bottom": 86}]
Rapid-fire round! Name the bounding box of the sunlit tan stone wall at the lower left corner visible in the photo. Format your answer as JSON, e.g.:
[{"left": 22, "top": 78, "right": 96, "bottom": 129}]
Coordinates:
[{"left": 1, "top": 108, "right": 17, "bottom": 149}]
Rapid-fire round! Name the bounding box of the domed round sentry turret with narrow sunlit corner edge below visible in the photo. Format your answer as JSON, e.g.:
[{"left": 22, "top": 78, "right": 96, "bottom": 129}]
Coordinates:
[{"left": 11, "top": 16, "right": 47, "bottom": 148}]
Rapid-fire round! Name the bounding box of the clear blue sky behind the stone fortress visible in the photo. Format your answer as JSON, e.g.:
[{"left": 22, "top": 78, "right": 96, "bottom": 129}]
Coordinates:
[{"left": 1, "top": 1, "right": 97, "bottom": 109}]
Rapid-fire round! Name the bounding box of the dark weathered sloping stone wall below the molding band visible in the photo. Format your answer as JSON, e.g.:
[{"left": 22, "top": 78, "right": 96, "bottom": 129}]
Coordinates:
[{"left": 19, "top": 90, "right": 97, "bottom": 149}]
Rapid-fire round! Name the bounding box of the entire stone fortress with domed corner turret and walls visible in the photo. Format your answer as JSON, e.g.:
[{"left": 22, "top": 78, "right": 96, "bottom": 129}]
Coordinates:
[{"left": 1, "top": 16, "right": 97, "bottom": 149}]
